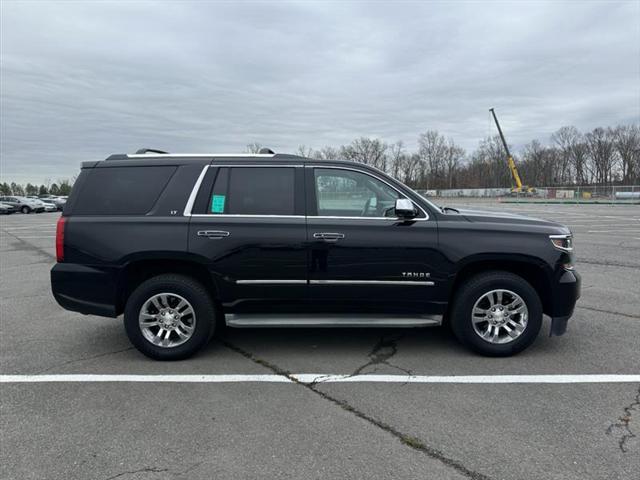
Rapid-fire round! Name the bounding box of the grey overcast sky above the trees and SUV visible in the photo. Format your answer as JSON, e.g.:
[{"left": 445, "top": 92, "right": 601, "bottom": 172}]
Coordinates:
[{"left": 0, "top": 0, "right": 640, "bottom": 182}]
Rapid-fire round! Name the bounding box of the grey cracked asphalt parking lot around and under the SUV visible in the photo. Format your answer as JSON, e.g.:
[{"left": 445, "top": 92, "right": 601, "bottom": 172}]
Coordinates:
[{"left": 0, "top": 200, "right": 640, "bottom": 480}]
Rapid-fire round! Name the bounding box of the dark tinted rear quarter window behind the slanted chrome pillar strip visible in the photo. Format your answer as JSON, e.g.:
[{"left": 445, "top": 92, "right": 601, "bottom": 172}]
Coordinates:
[{"left": 73, "top": 166, "right": 176, "bottom": 215}]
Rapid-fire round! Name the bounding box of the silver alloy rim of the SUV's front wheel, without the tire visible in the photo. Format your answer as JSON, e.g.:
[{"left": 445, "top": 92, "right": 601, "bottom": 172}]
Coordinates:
[{"left": 471, "top": 290, "right": 529, "bottom": 344}]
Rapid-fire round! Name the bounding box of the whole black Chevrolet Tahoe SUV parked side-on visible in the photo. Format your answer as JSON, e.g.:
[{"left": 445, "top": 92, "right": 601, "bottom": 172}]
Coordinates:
[{"left": 51, "top": 150, "right": 580, "bottom": 360}]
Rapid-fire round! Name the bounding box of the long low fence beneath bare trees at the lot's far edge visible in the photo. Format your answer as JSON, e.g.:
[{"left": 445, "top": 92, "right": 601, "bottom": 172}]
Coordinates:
[{"left": 418, "top": 185, "right": 640, "bottom": 204}]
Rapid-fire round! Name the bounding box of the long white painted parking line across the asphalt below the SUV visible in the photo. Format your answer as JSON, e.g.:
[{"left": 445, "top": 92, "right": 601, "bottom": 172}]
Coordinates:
[{"left": 0, "top": 373, "right": 640, "bottom": 384}]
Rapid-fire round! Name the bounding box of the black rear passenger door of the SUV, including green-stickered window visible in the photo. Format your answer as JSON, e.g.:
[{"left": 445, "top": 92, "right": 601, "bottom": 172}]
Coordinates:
[{"left": 188, "top": 164, "right": 307, "bottom": 313}]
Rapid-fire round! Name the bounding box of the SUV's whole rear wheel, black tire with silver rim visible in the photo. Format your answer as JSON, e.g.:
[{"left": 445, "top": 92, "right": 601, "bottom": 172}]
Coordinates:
[{"left": 124, "top": 274, "right": 216, "bottom": 360}]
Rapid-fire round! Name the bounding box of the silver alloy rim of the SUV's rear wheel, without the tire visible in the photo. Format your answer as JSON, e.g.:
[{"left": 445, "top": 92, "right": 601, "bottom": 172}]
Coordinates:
[{"left": 138, "top": 293, "right": 196, "bottom": 348}]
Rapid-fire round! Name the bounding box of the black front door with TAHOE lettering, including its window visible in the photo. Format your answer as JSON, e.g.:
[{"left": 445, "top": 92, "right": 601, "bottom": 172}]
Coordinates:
[{"left": 305, "top": 166, "right": 441, "bottom": 313}]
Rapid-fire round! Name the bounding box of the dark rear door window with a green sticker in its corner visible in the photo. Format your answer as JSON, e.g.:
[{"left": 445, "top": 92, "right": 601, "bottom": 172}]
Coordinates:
[{"left": 209, "top": 167, "right": 295, "bottom": 215}]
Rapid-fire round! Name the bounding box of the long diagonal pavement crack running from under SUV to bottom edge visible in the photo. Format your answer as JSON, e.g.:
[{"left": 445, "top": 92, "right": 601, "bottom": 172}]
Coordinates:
[{"left": 219, "top": 339, "right": 491, "bottom": 480}]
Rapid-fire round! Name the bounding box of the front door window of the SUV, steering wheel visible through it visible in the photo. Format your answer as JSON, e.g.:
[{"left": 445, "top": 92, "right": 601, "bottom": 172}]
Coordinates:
[{"left": 314, "top": 168, "right": 400, "bottom": 217}]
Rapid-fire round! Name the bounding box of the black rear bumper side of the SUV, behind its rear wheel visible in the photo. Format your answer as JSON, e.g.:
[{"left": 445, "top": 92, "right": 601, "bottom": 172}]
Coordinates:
[{"left": 51, "top": 263, "right": 117, "bottom": 317}]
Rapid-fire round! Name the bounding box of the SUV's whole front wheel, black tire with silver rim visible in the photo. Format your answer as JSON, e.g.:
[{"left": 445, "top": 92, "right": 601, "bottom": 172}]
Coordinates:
[{"left": 451, "top": 271, "right": 542, "bottom": 357}]
